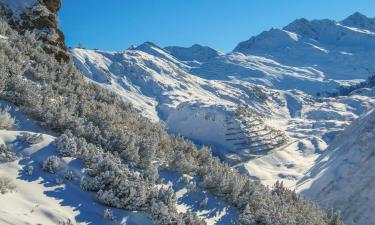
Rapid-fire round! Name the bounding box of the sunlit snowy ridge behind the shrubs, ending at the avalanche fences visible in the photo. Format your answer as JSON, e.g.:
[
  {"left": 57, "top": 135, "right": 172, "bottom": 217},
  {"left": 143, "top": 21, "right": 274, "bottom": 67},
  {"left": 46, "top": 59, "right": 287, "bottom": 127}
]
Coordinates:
[{"left": 71, "top": 46, "right": 294, "bottom": 160}]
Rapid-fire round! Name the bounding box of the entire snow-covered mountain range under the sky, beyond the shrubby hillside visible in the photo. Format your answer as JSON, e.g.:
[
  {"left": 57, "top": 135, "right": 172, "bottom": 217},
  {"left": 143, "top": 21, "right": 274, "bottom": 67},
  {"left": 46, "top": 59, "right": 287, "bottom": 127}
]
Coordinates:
[{"left": 70, "top": 13, "right": 375, "bottom": 224}]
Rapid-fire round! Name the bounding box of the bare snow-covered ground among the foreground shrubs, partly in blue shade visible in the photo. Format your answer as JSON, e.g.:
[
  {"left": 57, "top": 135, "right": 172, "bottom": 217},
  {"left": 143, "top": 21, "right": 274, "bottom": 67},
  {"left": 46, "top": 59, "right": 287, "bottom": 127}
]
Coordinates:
[{"left": 0, "top": 101, "right": 237, "bottom": 225}]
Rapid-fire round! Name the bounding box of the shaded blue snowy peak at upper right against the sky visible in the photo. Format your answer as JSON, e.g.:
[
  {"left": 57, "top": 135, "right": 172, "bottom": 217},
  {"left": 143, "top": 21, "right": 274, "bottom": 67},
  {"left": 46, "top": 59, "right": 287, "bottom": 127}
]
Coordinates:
[{"left": 234, "top": 13, "right": 375, "bottom": 80}]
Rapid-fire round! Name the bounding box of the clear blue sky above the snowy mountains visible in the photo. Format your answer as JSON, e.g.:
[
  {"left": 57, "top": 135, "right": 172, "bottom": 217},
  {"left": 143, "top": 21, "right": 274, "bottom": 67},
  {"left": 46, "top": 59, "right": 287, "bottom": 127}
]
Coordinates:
[{"left": 59, "top": 0, "right": 375, "bottom": 52}]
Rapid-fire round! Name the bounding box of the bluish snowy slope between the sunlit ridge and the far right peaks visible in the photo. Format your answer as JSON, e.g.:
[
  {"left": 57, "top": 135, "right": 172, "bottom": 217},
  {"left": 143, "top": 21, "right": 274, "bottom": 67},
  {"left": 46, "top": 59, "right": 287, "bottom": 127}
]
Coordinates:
[{"left": 190, "top": 52, "right": 345, "bottom": 95}]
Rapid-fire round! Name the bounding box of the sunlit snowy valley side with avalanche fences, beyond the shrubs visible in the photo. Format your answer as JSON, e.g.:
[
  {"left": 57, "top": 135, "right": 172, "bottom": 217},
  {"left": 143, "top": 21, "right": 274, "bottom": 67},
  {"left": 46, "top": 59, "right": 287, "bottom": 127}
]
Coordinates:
[{"left": 71, "top": 40, "right": 375, "bottom": 188}]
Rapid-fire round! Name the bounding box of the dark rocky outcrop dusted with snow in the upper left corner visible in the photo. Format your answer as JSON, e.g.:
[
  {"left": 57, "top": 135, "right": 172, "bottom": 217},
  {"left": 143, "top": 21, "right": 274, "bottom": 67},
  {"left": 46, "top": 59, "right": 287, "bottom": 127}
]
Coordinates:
[{"left": 0, "top": 0, "right": 70, "bottom": 61}]
